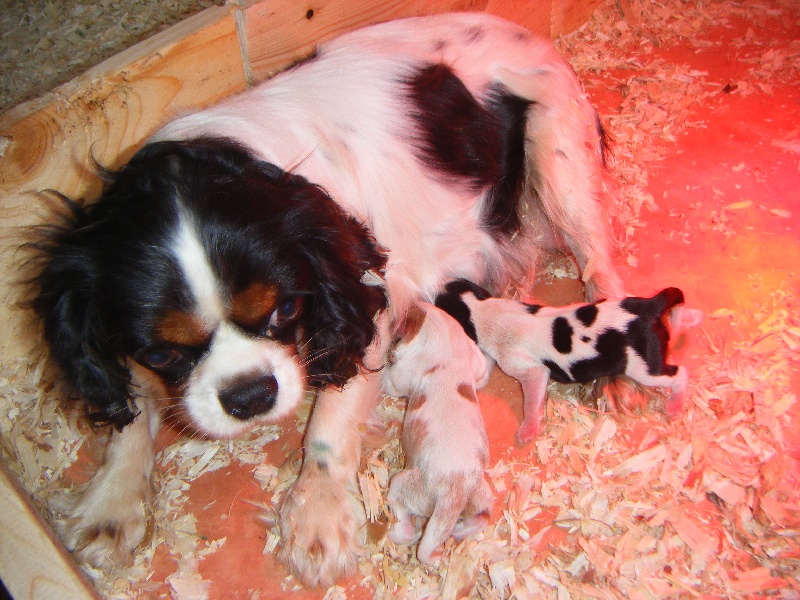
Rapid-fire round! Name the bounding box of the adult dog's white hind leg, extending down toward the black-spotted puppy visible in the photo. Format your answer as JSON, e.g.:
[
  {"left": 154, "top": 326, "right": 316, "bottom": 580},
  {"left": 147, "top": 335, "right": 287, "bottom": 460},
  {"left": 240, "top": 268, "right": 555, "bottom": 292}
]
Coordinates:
[{"left": 496, "top": 61, "right": 623, "bottom": 300}]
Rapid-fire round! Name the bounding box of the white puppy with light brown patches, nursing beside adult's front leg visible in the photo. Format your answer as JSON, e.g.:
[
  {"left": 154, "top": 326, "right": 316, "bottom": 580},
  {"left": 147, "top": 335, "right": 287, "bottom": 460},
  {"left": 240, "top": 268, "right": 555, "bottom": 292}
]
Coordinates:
[{"left": 384, "top": 303, "right": 493, "bottom": 564}]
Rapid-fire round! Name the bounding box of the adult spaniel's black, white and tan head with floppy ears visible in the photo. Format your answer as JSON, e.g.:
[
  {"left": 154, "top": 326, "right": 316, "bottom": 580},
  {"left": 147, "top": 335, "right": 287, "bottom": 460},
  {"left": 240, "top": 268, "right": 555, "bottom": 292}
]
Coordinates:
[{"left": 34, "top": 139, "right": 386, "bottom": 437}]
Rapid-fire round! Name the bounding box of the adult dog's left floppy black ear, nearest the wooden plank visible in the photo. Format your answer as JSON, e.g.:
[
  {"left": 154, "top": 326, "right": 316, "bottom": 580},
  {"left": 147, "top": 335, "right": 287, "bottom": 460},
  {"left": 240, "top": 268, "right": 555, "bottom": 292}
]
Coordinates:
[{"left": 32, "top": 198, "right": 136, "bottom": 429}]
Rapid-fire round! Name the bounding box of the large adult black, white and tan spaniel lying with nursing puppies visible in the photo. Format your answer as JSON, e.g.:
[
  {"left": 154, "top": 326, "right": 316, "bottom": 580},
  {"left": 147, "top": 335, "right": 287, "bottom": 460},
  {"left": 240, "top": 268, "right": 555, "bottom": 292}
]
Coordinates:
[{"left": 35, "top": 14, "right": 622, "bottom": 585}]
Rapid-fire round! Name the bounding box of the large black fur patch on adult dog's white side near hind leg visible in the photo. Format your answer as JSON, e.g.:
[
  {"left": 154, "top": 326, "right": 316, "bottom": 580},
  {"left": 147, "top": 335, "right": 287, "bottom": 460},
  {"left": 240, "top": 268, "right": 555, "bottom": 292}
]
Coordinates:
[{"left": 404, "top": 64, "right": 531, "bottom": 235}]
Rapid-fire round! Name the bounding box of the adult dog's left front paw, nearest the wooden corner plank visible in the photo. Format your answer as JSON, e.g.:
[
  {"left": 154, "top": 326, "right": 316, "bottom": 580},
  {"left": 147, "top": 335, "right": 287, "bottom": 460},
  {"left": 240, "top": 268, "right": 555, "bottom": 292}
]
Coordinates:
[{"left": 64, "top": 481, "right": 149, "bottom": 570}]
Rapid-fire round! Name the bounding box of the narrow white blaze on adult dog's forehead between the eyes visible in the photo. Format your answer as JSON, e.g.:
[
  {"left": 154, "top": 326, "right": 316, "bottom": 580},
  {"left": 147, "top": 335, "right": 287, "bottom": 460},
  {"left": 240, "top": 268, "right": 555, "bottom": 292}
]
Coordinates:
[{"left": 172, "top": 214, "right": 225, "bottom": 323}]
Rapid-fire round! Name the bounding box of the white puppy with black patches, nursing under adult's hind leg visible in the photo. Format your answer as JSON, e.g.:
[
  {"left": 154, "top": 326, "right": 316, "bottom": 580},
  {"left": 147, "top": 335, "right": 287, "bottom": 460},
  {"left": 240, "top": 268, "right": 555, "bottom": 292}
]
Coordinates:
[{"left": 436, "top": 280, "right": 703, "bottom": 443}]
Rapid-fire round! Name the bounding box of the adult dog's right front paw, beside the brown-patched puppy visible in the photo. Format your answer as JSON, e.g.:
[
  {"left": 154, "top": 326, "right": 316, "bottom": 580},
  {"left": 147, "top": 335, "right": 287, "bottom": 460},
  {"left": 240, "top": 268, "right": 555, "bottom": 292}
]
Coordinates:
[{"left": 279, "top": 465, "right": 366, "bottom": 587}]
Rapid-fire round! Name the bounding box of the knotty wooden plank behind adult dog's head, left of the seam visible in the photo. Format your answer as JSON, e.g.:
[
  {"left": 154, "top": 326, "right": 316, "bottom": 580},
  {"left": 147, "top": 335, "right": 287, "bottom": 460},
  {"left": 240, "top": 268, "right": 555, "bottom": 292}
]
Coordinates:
[{"left": 0, "top": 7, "right": 245, "bottom": 362}]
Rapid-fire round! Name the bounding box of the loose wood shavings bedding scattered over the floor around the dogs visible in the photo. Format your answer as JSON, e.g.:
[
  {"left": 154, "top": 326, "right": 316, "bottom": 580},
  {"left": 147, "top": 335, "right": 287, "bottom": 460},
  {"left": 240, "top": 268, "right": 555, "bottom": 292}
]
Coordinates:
[{"left": 0, "top": 0, "right": 800, "bottom": 600}]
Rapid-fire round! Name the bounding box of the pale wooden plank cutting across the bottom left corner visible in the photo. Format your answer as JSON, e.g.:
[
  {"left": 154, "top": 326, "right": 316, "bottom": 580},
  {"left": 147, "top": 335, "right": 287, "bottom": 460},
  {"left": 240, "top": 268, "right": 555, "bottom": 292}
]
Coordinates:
[{"left": 0, "top": 460, "right": 100, "bottom": 600}]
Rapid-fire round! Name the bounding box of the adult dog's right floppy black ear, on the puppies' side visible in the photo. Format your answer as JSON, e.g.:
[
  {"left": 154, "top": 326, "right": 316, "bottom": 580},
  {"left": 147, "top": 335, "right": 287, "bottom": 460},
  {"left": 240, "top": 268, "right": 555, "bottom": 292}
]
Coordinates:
[{"left": 288, "top": 183, "right": 386, "bottom": 386}]
